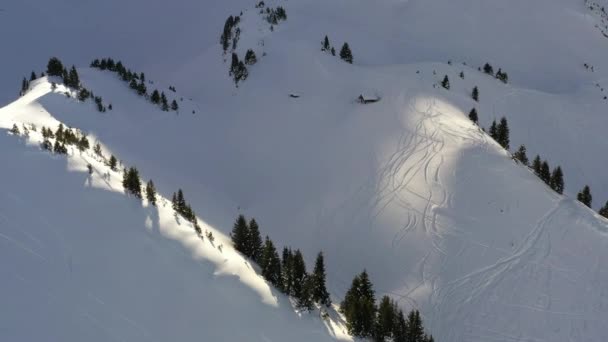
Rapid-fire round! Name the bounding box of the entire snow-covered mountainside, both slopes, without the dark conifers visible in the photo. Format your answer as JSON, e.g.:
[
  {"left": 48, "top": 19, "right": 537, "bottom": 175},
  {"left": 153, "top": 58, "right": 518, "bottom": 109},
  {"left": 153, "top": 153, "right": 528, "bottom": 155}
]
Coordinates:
[{"left": 0, "top": 0, "right": 608, "bottom": 341}]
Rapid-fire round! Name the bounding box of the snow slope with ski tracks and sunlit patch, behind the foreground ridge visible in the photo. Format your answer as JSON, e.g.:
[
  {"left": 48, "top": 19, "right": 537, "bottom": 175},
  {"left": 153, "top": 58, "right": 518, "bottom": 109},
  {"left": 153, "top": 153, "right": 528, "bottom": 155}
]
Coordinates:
[{"left": 0, "top": 0, "right": 608, "bottom": 341}]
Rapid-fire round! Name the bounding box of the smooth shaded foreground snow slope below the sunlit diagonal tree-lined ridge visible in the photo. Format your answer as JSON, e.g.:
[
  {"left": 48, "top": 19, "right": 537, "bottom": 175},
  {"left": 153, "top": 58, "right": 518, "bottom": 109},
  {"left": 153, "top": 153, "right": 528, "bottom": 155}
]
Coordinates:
[{"left": 0, "top": 82, "right": 349, "bottom": 341}]
